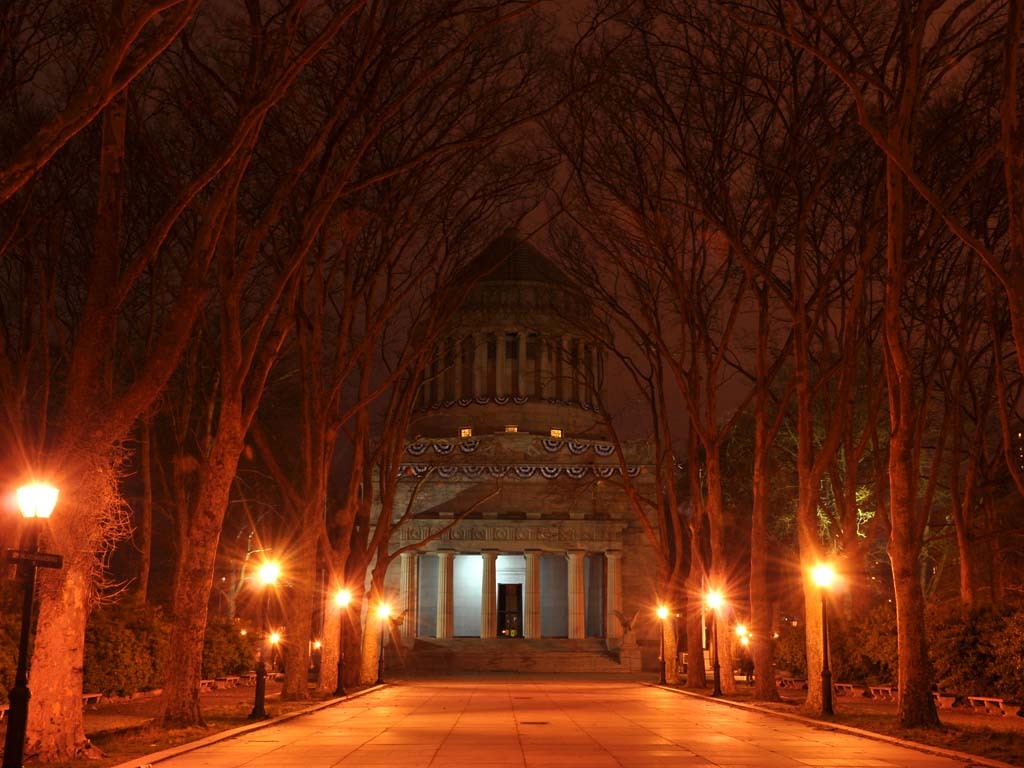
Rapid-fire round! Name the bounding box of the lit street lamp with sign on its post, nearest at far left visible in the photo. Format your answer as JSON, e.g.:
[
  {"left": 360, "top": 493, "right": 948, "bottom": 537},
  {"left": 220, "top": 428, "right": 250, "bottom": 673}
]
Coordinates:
[{"left": 3, "top": 483, "right": 61, "bottom": 768}]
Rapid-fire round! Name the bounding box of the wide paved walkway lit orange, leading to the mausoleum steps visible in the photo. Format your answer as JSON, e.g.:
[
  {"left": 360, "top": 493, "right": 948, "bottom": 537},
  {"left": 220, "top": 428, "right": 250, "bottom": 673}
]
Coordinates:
[{"left": 139, "top": 677, "right": 965, "bottom": 768}]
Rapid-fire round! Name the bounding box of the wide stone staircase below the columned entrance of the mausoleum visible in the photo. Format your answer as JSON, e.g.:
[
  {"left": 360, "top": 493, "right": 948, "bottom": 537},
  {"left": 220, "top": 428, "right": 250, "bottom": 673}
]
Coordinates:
[{"left": 387, "top": 638, "right": 628, "bottom": 675}]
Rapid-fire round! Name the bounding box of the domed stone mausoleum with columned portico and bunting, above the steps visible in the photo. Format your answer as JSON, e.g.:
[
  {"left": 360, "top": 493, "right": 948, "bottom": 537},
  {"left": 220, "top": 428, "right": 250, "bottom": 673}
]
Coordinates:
[{"left": 378, "top": 233, "right": 654, "bottom": 671}]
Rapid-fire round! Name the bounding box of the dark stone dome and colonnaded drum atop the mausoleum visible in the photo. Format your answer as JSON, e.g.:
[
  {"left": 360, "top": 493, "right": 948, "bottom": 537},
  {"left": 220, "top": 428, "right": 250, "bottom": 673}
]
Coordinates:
[{"left": 410, "top": 231, "right": 606, "bottom": 438}]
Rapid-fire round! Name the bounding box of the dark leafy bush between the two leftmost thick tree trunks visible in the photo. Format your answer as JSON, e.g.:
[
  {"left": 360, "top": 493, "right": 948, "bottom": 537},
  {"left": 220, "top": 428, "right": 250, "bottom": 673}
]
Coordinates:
[{"left": 83, "top": 603, "right": 169, "bottom": 696}]
